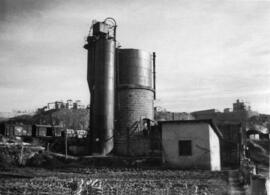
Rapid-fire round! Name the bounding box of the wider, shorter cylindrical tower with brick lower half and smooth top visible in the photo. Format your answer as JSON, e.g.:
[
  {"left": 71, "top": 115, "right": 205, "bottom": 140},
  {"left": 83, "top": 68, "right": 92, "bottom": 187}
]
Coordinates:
[{"left": 114, "top": 49, "right": 155, "bottom": 156}]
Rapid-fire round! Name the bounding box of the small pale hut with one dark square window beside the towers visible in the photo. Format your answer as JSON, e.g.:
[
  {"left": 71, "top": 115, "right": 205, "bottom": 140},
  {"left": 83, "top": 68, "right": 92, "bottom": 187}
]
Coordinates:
[{"left": 160, "top": 120, "right": 222, "bottom": 171}]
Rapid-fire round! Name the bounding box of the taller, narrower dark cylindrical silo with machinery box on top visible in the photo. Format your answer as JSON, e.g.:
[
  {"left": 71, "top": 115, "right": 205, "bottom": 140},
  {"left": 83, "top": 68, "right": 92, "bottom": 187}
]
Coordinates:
[{"left": 84, "top": 20, "right": 116, "bottom": 155}]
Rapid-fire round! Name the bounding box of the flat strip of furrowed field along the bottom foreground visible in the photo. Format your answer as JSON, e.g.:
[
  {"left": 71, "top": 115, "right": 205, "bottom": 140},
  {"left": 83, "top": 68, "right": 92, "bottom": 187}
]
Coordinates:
[{"left": 0, "top": 167, "right": 227, "bottom": 195}]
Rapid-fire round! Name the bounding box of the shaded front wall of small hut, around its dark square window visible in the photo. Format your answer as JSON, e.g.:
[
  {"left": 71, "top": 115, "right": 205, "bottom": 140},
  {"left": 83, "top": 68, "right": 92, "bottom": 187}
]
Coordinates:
[{"left": 162, "top": 123, "right": 211, "bottom": 169}]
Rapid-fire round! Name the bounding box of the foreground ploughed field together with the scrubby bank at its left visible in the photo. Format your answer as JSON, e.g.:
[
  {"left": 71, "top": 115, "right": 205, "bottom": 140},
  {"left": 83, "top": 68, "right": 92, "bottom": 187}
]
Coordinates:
[{"left": 0, "top": 137, "right": 228, "bottom": 195}]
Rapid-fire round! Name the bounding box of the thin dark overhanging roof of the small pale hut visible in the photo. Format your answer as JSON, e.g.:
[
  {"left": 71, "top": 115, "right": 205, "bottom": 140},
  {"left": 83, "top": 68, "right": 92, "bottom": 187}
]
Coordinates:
[{"left": 159, "top": 119, "right": 223, "bottom": 139}]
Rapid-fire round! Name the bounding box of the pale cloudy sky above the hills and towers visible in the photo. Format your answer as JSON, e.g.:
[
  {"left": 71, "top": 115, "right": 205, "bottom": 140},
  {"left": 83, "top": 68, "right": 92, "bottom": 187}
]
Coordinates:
[{"left": 0, "top": 0, "right": 270, "bottom": 114}]
